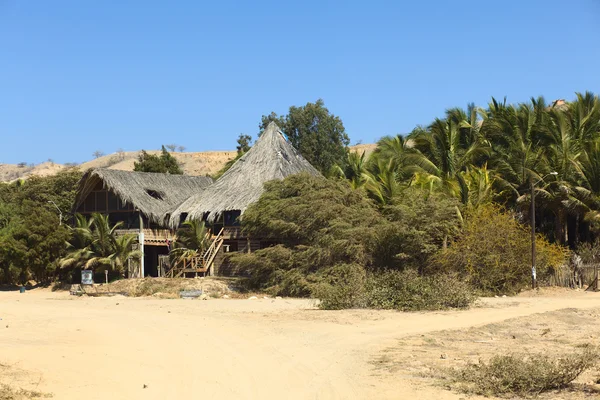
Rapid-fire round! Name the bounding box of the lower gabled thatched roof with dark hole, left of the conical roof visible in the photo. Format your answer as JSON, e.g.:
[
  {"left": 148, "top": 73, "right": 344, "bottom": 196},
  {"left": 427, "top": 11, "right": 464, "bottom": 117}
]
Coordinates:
[{"left": 74, "top": 168, "right": 213, "bottom": 224}]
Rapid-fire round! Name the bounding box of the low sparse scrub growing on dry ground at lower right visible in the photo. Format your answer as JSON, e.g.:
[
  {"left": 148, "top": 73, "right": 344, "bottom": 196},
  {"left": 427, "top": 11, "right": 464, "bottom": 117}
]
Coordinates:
[{"left": 452, "top": 346, "right": 600, "bottom": 396}]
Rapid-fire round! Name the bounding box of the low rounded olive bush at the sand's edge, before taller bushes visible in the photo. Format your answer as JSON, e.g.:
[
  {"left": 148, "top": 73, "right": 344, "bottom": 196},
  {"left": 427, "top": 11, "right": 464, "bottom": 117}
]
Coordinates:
[{"left": 366, "top": 270, "right": 476, "bottom": 311}]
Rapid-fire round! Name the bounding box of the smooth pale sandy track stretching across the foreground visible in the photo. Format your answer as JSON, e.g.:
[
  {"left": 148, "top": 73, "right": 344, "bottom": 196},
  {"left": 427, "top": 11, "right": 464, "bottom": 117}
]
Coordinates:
[{"left": 0, "top": 289, "right": 600, "bottom": 400}]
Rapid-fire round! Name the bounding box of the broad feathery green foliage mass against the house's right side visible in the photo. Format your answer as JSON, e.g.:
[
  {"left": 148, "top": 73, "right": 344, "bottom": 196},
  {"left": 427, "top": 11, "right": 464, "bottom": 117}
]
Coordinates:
[{"left": 233, "top": 174, "right": 460, "bottom": 296}]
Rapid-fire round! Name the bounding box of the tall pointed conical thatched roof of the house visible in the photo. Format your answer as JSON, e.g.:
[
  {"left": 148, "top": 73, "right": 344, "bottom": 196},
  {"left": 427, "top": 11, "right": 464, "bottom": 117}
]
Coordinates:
[{"left": 169, "top": 122, "right": 319, "bottom": 226}]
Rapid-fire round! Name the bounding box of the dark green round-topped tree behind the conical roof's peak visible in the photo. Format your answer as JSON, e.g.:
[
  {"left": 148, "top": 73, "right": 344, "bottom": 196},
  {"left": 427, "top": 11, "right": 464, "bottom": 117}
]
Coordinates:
[{"left": 259, "top": 99, "right": 350, "bottom": 174}]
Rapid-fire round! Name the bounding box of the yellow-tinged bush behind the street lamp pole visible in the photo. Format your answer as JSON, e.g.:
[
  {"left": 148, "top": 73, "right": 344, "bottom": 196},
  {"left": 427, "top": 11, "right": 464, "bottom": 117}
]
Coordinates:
[{"left": 430, "top": 205, "right": 568, "bottom": 293}]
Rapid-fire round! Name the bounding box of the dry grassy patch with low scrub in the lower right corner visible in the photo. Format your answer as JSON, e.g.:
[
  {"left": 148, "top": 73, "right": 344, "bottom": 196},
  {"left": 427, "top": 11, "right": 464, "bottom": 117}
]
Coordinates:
[{"left": 373, "top": 309, "right": 600, "bottom": 400}]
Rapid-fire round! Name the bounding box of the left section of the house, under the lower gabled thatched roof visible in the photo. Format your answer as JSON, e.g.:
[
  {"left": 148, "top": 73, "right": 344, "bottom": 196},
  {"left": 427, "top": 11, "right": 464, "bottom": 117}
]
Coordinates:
[{"left": 73, "top": 169, "right": 213, "bottom": 276}]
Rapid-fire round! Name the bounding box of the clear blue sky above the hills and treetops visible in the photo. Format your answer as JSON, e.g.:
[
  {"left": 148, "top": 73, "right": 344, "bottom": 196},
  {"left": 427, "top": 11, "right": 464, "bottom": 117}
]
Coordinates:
[{"left": 0, "top": 0, "right": 600, "bottom": 163}]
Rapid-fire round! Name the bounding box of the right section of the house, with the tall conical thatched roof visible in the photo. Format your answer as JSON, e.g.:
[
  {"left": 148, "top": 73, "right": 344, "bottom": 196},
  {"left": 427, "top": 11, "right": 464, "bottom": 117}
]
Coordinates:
[{"left": 168, "top": 122, "right": 320, "bottom": 273}]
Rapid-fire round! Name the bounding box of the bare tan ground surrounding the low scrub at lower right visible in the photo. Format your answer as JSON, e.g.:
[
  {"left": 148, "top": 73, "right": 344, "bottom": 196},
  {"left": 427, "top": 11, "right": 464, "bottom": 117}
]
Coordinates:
[{"left": 372, "top": 308, "right": 600, "bottom": 400}]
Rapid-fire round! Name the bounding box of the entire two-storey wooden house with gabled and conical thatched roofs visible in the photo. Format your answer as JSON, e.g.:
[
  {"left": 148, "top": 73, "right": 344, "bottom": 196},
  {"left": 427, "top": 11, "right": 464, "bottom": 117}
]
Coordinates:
[{"left": 74, "top": 123, "right": 320, "bottom": 277}]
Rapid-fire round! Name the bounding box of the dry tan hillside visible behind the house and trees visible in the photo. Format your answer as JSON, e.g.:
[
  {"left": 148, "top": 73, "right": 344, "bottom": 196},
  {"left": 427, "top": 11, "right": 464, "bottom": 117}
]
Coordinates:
[{"left": 0, "top": 144, "right": 375, "bottom": 182}]
